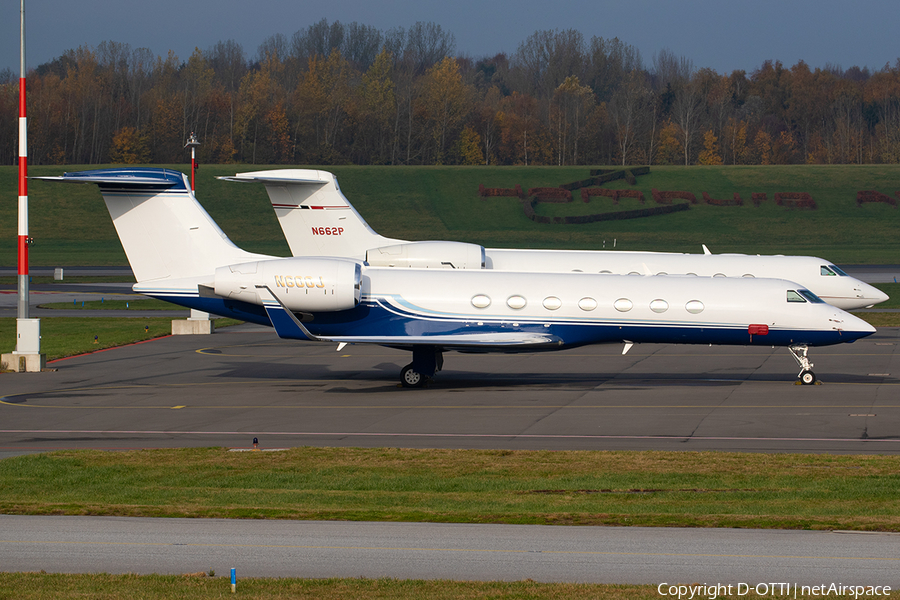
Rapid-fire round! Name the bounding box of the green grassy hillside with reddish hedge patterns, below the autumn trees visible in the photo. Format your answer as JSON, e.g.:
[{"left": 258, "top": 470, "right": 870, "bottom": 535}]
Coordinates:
[{"left": 0, "top": 165, "right": 900, "bottom": 266}]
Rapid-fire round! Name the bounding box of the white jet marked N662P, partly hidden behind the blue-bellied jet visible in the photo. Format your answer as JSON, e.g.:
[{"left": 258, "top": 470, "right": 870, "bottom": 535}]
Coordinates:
[{"left": 221, "top": 169, "right": 888, "bottom": 310}]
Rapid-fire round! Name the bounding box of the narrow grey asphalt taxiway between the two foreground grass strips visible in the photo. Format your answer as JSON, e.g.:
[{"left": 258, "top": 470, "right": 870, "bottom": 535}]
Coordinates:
[{"left": 0, "top": 515, "right": 900, "bottom": 584}]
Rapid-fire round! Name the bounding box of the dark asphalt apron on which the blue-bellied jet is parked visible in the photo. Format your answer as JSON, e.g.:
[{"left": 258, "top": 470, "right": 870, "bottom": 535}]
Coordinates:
[{"left": 0, "top": 325, "right": 900, "bottom": 456}]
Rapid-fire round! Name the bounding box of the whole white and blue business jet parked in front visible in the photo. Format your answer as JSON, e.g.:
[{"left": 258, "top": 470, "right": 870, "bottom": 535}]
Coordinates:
[{"left": 38, "top": 168, "right": 875, "bottom": 387}]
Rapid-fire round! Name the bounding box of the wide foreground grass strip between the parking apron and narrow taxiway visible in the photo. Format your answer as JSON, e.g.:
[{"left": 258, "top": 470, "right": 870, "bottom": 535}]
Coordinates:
[{"left": 0, "top": 448, "right": 900, "bottom": 531}]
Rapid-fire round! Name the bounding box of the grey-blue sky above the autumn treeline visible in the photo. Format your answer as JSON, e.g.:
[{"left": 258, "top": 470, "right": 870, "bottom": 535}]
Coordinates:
[{"left": 0, "top": 0, "right": 900, "bottom": 76}]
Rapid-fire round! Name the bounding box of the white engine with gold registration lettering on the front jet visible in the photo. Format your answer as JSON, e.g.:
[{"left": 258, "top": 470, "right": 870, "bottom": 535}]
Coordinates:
[{"left": 215, "top": 258, "right": 362, "bottom": 312}]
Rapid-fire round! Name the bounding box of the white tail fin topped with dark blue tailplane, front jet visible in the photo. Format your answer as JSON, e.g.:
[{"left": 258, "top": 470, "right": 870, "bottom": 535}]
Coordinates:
[{"left": 35, "top": 167, "right": 268, "bottom": 283}]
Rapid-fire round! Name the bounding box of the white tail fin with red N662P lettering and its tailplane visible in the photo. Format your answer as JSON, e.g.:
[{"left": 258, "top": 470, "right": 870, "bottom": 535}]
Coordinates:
[{"left": 219, "top": 169, "right": 403, "bottom": 260}]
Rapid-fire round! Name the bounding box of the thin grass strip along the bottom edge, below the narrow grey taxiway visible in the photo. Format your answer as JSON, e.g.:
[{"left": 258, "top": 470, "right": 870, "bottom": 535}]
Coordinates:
[{"left": 0, "top": 573, "right": 808, "bottom": 600}]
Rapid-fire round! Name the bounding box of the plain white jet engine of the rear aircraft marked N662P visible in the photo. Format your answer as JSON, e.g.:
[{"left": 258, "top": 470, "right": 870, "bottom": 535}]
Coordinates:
[{"left": 366, "top": 242, "right": 484, "bottom": 269}]
